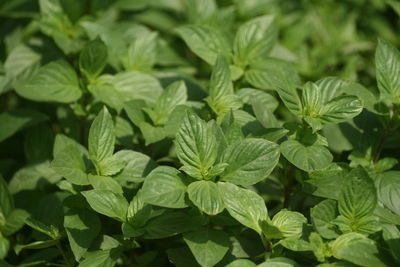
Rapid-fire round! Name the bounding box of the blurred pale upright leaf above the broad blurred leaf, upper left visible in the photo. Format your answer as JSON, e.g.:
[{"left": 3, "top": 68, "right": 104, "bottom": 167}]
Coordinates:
[{"left": 122, "top": 32, "right": 157, "bottom": 71}]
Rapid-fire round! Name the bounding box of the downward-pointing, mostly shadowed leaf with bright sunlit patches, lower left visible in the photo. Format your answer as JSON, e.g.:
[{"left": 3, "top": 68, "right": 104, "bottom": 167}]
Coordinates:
[{"left": 64, "top": 208, "right": 101, "bottom": 261}]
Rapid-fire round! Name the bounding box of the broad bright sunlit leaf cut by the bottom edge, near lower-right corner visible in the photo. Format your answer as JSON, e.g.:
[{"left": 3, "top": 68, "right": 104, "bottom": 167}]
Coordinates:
[{"left": 330, "top": 233, "right": 386, "bottom": 267}]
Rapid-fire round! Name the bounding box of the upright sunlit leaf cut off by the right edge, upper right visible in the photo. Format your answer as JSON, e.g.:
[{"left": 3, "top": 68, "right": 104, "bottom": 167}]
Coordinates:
[{"left": 375, "top": 39, "right": 400, "bottom": 102}]
